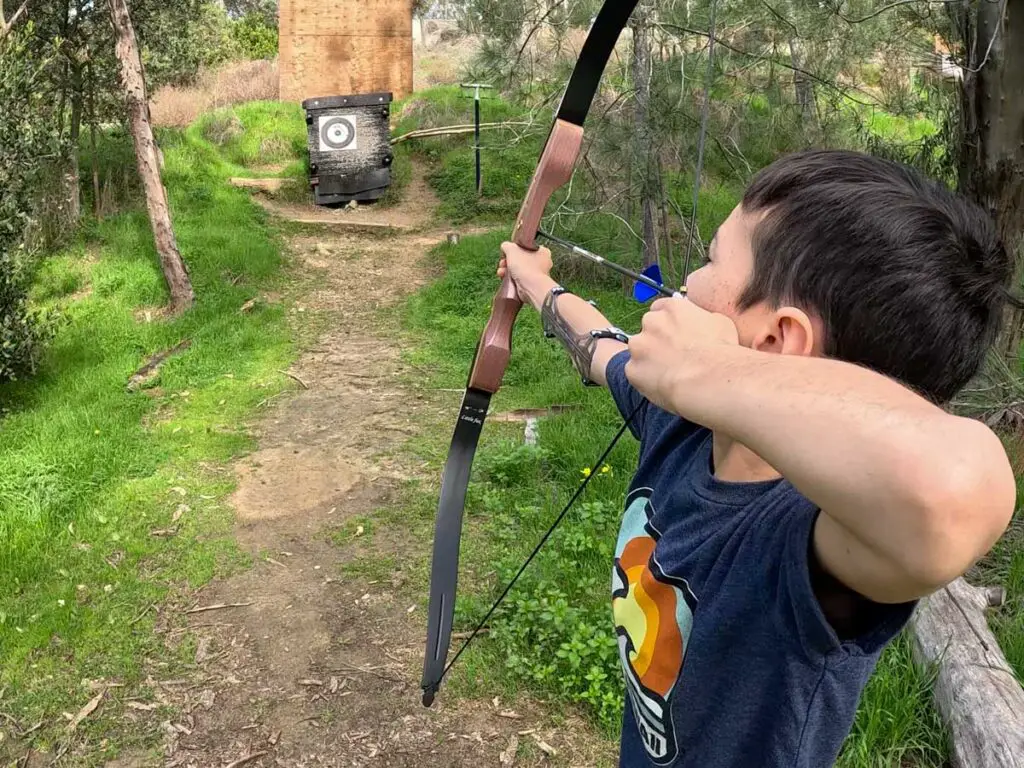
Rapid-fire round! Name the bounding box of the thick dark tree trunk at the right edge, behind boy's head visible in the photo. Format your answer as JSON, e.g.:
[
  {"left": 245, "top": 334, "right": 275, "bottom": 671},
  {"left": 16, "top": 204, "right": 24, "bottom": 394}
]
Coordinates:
[{"left": 959, "top": 0, "right": 1024, "bottom": 360}]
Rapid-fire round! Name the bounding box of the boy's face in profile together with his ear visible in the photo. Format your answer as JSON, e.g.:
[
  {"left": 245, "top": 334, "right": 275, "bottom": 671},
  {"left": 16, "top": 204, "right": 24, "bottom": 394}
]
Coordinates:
[{"left": 686, "top": 205, "right": 824, "bottom": 353}]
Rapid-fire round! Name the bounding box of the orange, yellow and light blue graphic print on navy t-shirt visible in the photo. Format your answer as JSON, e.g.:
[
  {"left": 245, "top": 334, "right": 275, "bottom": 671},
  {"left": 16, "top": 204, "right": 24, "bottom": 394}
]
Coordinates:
[{"left": 611, "top": 488, "right": 697, "bottom": 765}]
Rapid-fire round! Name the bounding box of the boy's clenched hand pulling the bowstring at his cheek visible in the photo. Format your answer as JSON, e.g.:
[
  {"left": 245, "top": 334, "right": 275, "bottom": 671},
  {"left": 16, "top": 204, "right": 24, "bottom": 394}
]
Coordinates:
[{"left": 626, "top": 297, "right": 739, "bottom": 411}]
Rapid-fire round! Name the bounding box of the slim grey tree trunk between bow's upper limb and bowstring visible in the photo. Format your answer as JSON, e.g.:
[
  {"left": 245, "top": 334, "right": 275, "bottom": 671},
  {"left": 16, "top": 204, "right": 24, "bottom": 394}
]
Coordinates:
[{"left": 632, "top": 0, "right": 659, "bottom": 266}]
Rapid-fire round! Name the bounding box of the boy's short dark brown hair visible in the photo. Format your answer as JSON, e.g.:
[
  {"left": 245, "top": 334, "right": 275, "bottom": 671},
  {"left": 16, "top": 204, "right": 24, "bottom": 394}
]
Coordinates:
[{"left": 739, "top": 151, "right": 1016, "bottom": 403}]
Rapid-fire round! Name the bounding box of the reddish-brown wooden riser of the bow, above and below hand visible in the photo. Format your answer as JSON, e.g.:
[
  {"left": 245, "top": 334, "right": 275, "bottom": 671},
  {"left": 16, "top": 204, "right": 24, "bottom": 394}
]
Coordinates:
[{"left": 467, "top": 120, "right": 583, "bottom": 394}]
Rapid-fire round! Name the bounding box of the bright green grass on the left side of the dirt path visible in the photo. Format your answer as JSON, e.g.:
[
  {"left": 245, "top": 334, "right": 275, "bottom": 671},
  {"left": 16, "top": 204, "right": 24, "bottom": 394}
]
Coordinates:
[{"left": 0, "top": 108, "right": 296, "bottom": 765}]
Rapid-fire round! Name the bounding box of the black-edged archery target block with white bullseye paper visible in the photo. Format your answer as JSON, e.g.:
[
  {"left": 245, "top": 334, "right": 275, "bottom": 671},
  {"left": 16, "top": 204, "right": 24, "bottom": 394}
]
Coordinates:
[{"left": 302, "top": 93, "right": 394, "bottom": 206}]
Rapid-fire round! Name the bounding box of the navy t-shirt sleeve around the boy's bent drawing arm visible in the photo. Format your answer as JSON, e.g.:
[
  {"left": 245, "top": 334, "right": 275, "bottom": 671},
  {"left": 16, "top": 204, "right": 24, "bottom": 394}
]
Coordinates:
[{"left": 758, "top": 503, "right": 916, "bottom": 655}]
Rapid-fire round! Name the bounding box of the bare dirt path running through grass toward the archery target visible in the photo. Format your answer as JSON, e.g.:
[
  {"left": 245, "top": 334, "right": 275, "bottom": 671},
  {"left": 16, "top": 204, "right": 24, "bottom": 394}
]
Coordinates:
[{"left": 116, "top": 165, "right": 608, "bottom": 768}]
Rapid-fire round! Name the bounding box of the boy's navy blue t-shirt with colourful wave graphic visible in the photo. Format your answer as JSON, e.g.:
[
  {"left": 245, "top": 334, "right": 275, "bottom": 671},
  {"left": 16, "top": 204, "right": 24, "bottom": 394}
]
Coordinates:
[{"left": 607, "top": 351, "right": 913, "bottom": 768}]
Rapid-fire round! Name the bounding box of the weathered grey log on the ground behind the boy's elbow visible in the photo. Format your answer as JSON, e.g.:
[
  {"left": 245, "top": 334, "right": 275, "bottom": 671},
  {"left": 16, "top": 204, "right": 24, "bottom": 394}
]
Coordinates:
[{"left": 910, "top": 579, "right": 1024, "bottom": 768}]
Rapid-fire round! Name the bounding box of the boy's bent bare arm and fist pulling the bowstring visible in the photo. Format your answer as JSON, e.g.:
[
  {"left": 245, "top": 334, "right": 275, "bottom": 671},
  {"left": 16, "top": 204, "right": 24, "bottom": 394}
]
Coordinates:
[{"left": 626, "top": 299, "right": 1017, "bottom": 602}]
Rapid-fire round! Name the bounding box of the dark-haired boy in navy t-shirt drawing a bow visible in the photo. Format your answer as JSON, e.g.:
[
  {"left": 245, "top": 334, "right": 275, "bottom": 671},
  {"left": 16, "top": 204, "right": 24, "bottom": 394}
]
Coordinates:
[{"left": 498, "top": 152, "right": 1017, "bottom": 768}]
